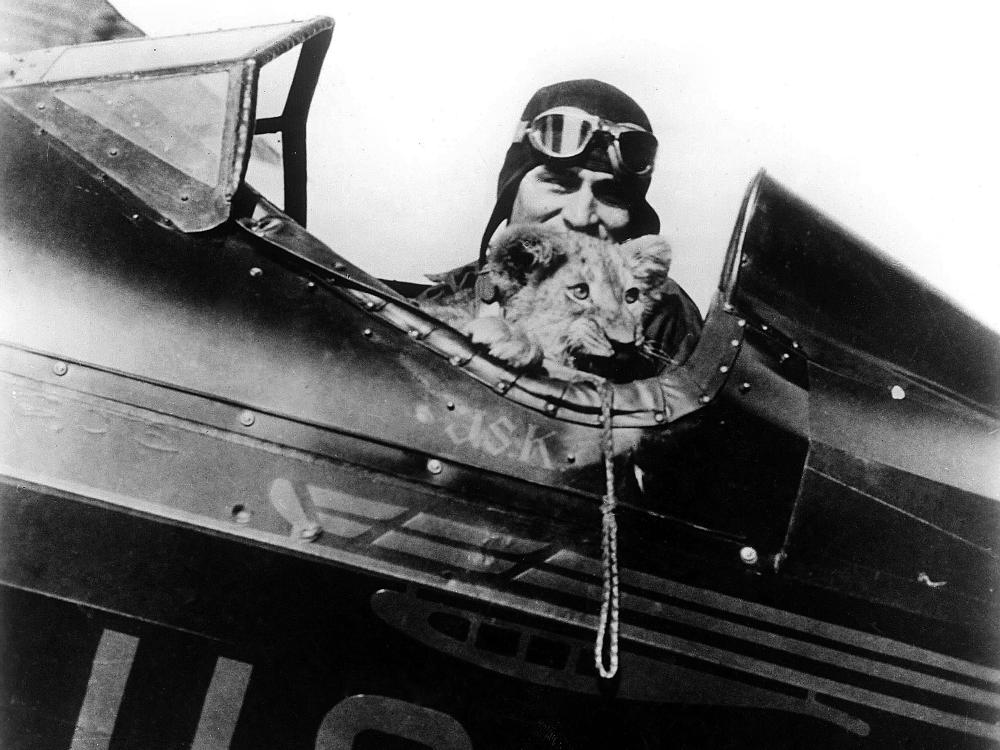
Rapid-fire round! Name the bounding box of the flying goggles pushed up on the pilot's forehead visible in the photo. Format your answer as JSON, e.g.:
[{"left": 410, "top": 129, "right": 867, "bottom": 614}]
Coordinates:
[{"left": 514, "top": 107, "right": 657, "bottom": 176}]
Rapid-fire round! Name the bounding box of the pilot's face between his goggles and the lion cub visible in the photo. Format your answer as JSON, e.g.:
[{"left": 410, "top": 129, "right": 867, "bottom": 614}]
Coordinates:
[{"left": 509, "top": 164, "right": 631, "bottom": 241}]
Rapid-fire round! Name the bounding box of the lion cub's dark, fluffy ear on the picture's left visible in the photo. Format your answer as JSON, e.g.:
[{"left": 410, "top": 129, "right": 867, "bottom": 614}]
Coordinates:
[{"left": 487, "top": 224, "right": 566, "bottom": 298}]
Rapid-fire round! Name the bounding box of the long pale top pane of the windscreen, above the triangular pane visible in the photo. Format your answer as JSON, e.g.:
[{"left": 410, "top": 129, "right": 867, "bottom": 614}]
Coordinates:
[{"left": 43, "top": 22, "right": 302, "bottom": 82}]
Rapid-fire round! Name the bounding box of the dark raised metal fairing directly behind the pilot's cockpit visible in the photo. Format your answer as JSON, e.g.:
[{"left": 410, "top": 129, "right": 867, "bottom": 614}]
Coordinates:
[{"left": 731, "top": 173, "right": 1000, "bottom": 416}]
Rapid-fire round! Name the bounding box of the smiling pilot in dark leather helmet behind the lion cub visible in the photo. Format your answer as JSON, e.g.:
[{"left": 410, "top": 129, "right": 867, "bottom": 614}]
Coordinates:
[{"left": 420, "top": 79, "right": 702, "bottom": 380}]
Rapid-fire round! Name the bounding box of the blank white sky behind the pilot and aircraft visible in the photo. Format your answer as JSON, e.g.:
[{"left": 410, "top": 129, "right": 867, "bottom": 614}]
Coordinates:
[{"left": 113, "top": 0, "right": 1000, "bottom": 330}]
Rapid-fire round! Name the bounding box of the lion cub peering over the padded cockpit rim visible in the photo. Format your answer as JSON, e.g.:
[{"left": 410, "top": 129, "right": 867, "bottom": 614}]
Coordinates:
[{"left": 429, "top": 224, "right": 671, "bottom": 375}]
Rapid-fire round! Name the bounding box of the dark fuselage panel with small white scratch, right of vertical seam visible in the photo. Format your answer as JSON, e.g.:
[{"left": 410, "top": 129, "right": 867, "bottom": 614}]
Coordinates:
[{"left": 783, "top": 446, "right": 1000, "bottom": 628}]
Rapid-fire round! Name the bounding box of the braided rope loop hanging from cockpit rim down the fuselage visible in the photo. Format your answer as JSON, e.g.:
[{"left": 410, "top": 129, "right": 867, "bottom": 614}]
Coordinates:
[{"left": 594, "top": 382, "right": 619, "bottom": 680}]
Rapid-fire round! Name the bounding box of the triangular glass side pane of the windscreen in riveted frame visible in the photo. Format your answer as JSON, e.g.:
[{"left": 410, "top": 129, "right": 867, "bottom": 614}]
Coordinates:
[{"left": 54, "top": 71, "right": 229, "bottom": 186}]
